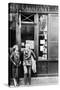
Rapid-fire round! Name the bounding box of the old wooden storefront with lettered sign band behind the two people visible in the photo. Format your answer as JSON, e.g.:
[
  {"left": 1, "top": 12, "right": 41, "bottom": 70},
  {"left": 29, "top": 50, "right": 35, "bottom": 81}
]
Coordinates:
[{"left": 9, "top": 3, "right": 58, "bottom": 79}]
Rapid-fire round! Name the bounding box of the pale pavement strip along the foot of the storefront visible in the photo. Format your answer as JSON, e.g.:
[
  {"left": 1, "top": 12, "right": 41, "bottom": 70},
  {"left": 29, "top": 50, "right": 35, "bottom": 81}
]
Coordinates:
[{"left": 11, "top": 76, "right": 58, "bottom": 86}]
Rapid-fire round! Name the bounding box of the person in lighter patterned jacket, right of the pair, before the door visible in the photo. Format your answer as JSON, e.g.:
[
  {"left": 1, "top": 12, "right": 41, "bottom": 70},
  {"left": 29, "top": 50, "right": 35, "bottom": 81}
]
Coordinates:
[{"left": 23, "top": 46, "right": 35, "bottom": 85}]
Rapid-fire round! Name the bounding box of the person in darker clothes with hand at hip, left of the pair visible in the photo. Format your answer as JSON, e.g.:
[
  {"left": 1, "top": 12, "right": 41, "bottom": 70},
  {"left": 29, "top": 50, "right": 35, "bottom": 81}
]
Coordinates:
[{"left": 10, "top": 45, "right": 21, "bottom": 86}]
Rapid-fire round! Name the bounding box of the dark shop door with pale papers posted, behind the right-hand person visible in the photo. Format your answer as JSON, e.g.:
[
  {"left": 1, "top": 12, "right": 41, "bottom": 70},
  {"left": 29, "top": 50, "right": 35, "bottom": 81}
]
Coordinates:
[{"left": 20, "top": 23, "right": 35, "bottom": 77}]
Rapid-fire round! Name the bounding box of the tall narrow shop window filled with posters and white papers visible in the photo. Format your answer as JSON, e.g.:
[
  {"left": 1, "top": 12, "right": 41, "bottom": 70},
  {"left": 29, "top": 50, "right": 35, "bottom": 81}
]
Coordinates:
[{"left": 39, "top": 15, "right": 47, "bottom": 60}]
